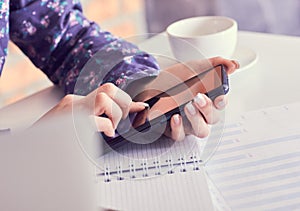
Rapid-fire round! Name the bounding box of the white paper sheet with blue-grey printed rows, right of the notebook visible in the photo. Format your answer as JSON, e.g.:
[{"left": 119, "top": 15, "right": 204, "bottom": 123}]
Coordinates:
[{"left": 206, "top": 103, "right": 300, "bottom": 210}]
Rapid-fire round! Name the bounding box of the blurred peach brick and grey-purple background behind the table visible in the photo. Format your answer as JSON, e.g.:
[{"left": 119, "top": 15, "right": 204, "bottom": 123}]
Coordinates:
[{"left": 0, "top": 0, "right": 300, "bottom": 108}]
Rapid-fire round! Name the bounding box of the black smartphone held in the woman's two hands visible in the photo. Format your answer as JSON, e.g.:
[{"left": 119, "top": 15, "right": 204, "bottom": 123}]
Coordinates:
[{"left": 102, "top": 65, "right": 229, "bottom": 151}]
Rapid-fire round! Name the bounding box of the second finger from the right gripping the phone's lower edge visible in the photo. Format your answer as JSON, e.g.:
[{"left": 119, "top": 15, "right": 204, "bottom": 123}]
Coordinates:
[{"left": 193, "top": 93, "right": 219, "bottom": 124}]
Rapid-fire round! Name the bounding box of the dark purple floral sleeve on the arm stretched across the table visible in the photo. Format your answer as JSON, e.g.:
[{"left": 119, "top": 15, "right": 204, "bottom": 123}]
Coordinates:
[{"left": 10, "top": 0, "right": 159, "bottom": 95}]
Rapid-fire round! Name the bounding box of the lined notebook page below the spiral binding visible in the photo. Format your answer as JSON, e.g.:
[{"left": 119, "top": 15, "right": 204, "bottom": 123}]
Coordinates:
[{"left": 99, "top": 169, "right": 214, "bottom": 211}]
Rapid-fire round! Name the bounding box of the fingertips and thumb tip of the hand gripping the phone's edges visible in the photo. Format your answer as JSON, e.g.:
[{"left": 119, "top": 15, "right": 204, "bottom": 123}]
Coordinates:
[{"left": 165, "top": 57, "right": 239, "bottom": 141}]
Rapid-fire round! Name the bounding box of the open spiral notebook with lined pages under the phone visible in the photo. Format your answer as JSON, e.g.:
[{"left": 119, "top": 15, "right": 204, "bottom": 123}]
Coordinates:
[{"left": 96, "top": 118, "right": 232, "bottom": 210}]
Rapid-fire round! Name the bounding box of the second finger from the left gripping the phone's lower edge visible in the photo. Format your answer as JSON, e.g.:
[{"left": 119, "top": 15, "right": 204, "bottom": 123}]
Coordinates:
[{"left": 184, "top": 102, "right": 209, "bottom": 138}]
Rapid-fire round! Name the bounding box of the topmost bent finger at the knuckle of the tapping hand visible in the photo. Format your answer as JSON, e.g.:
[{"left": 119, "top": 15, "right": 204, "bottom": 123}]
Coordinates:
[{"left": 97, "top": 83, "right": 132, "bottom": 119}]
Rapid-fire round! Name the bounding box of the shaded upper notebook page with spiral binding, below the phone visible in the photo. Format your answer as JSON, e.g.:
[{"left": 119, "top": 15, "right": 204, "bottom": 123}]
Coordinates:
[{"left": 98, "top": 137, "right": 204, "bottom": 182}]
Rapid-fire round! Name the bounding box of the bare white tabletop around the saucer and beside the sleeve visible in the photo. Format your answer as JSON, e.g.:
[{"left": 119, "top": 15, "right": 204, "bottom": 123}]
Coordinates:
[{"left": 0, "top": 32, "right": 300, "bottom": 130}]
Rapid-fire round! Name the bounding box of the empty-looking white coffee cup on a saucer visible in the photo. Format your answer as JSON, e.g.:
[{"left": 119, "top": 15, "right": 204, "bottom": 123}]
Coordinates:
[{"left": 166, "top": 16, "right": 238, "bottom": 61}]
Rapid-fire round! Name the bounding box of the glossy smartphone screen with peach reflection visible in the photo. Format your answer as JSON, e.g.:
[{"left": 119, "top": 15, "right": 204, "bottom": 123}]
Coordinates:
[{"left": 142, "top": 65, "right": 227, "bottom": 122}]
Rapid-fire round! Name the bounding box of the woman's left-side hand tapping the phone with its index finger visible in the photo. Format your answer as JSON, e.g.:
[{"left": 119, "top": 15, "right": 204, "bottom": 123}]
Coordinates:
[{"left": 41, "top": 83, "right": 145, "bottom": 137}]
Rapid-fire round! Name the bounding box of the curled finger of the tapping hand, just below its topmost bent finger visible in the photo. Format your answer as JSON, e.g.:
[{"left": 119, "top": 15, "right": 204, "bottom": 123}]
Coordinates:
[{"left": 94, "top": 92, "right": 122, "bottom": 129}]
